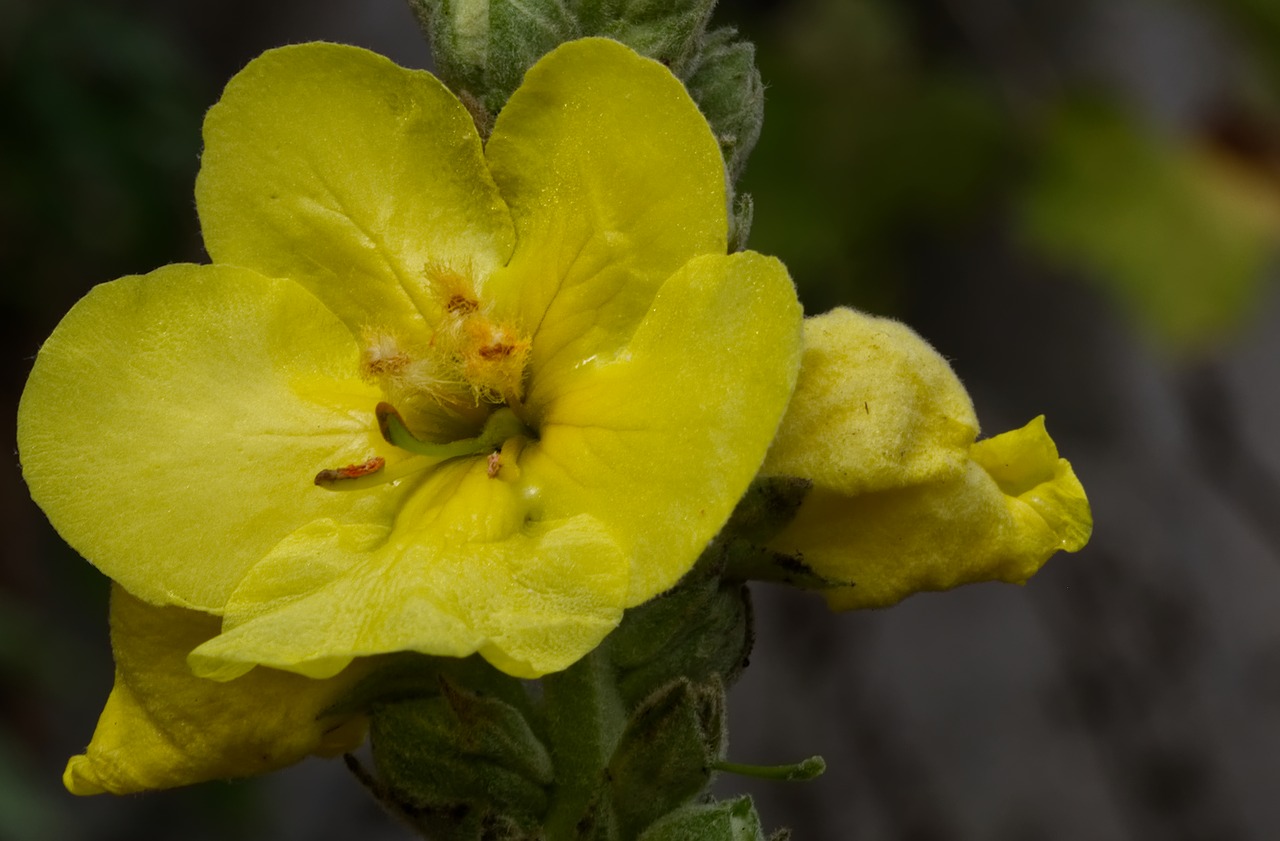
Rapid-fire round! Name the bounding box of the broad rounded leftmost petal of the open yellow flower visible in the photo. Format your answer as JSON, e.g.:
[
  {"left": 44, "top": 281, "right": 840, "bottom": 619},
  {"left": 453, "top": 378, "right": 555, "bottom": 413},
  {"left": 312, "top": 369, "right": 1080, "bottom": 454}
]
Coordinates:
[{"left": 18, "top": 265, "right": 399, "bottom": 613}]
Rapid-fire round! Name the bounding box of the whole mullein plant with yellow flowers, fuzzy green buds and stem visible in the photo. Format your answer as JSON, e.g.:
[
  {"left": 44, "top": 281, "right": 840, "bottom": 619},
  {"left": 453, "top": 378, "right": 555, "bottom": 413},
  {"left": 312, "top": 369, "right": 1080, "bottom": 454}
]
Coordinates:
[{"left": 18, "top": 0, "right": 1091, "bottom": 841}]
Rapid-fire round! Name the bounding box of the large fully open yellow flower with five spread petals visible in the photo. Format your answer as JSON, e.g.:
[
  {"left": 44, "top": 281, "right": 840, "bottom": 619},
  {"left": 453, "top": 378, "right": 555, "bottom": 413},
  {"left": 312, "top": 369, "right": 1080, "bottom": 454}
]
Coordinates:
[{"left": 18, "top": 40, "right": 801, "bottom": 791}]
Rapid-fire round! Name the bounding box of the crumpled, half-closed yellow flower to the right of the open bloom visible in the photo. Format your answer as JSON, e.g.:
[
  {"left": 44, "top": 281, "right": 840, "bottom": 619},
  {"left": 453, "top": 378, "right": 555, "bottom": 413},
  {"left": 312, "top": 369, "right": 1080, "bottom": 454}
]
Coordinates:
[{"left": 763, "top": 304, "right": 1093, "bottom": 609}]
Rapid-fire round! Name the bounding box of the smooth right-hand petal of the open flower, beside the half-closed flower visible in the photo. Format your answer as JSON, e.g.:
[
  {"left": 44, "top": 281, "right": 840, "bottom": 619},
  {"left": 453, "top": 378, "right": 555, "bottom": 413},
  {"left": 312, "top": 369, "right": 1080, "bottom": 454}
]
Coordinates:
[{"left": 521, "top": 252, "right": 801, "bottom": 605}]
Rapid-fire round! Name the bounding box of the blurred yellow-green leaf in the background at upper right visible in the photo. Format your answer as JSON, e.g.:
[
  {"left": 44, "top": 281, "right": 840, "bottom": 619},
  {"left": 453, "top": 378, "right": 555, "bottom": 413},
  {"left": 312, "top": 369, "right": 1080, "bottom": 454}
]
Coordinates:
[{"left": 1021, "top": 104, "right": 1280, "bottom": 348}]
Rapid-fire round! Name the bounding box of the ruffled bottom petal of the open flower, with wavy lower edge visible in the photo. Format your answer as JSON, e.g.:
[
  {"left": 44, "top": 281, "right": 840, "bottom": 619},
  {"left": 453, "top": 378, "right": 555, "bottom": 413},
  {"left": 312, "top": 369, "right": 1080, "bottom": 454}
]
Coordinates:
[{"left": 191, "top": 458, "right": 627, "bottom": 678}]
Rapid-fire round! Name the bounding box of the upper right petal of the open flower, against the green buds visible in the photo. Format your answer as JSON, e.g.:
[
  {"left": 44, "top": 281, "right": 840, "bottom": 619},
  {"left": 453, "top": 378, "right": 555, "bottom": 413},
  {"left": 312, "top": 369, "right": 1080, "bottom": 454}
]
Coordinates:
[{"left": 485, "top": 38, "right": 728, "bottom": 401}]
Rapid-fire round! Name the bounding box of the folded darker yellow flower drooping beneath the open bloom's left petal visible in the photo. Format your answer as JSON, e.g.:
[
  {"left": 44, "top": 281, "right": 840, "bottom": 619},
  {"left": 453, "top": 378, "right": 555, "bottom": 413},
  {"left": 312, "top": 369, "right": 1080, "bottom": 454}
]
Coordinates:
[{"left": 63, "top": 586, "right": 365, "bottom": 795}]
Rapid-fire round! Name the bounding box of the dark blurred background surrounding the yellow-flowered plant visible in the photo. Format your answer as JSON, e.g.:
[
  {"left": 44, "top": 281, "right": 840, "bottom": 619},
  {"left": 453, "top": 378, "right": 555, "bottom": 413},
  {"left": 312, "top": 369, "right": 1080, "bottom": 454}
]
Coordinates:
[{"left": 0, "top": 0, "right": 1280, "bottom": 841}]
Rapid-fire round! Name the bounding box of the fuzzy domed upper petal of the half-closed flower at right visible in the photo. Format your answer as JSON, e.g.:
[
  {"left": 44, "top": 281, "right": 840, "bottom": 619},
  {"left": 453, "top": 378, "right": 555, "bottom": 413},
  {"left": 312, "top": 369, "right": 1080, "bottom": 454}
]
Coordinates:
[{"left": 762, "top": 308, "right": 978, "bottom": 495}]
